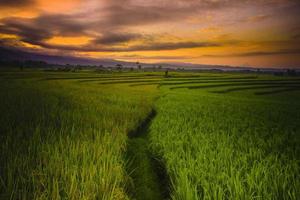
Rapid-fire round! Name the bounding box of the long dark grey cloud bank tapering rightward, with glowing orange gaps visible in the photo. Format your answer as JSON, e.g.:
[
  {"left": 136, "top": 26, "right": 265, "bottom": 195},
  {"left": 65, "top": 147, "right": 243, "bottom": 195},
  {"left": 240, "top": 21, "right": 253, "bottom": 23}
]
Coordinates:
[{"left": 0, "top": 14, "right": 220, "bottom": 52}]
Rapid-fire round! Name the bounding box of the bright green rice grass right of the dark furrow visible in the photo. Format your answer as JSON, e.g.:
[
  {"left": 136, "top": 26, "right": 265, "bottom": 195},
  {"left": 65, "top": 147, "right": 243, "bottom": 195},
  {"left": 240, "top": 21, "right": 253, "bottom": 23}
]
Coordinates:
[{"left": 149, "top": 84, "right": 300, "bottom": 199}]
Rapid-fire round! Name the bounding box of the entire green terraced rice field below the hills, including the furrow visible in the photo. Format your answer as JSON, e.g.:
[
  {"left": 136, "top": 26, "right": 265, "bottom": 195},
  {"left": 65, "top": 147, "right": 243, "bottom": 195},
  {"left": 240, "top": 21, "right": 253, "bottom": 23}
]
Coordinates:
[{"left": 0, "top": 70, "right": 300, "bottom": 199}]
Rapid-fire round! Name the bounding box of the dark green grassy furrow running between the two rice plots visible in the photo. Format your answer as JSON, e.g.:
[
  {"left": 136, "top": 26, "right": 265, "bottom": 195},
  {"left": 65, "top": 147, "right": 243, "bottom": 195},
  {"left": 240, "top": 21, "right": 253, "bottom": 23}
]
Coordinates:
[{"left": 126, "top": 110, "right": 170, "bottom": 200}]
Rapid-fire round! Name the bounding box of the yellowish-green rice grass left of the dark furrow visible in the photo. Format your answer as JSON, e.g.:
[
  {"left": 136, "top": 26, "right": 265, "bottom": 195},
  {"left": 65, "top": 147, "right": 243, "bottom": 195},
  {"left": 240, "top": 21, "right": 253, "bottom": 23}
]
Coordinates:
[{"left": 0, "top": 71, "right": 155, "bottom": 199}]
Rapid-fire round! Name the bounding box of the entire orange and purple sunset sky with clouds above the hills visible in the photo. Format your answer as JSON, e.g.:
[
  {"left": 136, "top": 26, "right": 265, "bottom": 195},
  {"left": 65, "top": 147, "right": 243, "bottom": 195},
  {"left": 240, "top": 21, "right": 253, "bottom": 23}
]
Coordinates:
[{"left": 0, "top": 0, "right": 300, "bottom": 68}]
